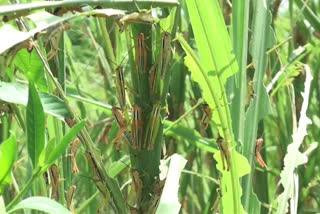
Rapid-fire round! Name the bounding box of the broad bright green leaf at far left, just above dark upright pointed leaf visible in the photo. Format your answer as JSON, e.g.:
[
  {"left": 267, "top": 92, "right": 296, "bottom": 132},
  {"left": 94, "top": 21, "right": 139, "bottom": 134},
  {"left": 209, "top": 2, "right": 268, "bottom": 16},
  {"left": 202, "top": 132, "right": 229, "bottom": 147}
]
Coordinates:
[{"left": 14, "top": 49, "right": 47, "bottom": 91}]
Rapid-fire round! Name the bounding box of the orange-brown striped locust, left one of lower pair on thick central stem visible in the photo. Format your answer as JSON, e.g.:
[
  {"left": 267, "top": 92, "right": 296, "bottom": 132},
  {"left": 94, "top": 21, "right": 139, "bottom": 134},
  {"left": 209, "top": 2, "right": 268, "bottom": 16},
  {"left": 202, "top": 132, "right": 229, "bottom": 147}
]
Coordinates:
[{"left": 131, "top": 104, "right": 143, "bottom": 150}]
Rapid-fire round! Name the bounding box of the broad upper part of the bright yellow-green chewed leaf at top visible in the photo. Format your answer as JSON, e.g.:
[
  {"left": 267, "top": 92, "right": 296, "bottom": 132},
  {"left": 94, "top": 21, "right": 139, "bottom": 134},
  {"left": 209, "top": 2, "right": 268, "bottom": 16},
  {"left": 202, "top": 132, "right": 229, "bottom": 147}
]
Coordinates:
[{"left": 182, "top": 0, "right": 238, "bottom": 137}]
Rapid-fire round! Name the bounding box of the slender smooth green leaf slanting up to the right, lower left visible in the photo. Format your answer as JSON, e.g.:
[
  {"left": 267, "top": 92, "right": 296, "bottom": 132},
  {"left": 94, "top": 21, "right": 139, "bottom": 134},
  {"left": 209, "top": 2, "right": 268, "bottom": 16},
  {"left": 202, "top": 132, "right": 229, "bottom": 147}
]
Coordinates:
[{"left": 46, "top": 121, "right": 86, "bottom": 165}]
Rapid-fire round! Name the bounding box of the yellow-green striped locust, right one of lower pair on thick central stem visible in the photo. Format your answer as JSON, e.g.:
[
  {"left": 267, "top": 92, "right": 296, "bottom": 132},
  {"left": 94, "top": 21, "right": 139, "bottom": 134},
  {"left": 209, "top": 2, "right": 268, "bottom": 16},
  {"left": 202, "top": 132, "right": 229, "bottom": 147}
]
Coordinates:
[{"left": 143, "top": 103, "right": 161, "bottom": 150}]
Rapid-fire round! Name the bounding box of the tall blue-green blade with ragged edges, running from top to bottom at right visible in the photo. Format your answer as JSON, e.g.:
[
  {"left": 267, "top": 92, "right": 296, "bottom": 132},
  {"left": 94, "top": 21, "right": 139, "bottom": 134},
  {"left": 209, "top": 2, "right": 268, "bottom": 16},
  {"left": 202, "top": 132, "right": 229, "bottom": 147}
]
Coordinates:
[{"left": 242, "top": 0, "right": 275, "bottom": 213}]
